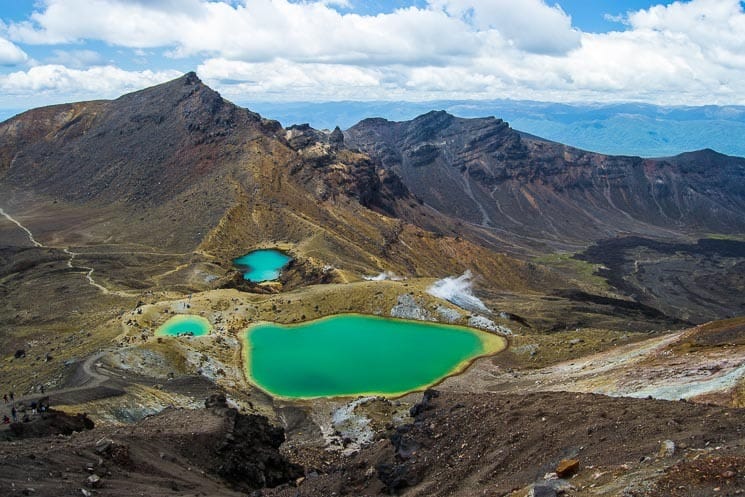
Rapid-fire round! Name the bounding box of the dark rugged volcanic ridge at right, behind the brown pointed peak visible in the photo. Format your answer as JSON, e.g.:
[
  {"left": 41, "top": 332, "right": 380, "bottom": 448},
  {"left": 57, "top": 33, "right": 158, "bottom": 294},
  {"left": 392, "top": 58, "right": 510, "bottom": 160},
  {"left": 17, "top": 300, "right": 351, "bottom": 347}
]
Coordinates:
[{"left": 345, "top": 111, "right": 745, "bottom": 250}]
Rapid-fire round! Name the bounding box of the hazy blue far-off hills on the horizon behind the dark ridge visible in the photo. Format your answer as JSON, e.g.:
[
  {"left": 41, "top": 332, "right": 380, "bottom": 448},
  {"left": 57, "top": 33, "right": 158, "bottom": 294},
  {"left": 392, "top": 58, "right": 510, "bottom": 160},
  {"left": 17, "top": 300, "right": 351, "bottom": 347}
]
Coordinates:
[{"left": 246, "top": 100, "right": 745, "bottom": 157}]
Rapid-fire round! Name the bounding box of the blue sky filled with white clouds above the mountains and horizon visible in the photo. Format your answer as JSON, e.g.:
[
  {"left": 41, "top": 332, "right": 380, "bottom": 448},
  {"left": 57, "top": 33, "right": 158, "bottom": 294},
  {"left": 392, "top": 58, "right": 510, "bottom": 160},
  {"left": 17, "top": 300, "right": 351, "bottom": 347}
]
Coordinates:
[{"left": 0, "top": 0, "right": 745, "bottom": 110}]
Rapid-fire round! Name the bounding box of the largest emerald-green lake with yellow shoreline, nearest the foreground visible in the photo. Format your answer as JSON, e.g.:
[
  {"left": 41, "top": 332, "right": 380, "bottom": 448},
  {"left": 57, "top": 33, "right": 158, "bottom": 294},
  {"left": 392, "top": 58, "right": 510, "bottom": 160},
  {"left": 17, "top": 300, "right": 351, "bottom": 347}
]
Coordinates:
[{"left": 244, "top": 314, "right": 506, "bottom": 398}]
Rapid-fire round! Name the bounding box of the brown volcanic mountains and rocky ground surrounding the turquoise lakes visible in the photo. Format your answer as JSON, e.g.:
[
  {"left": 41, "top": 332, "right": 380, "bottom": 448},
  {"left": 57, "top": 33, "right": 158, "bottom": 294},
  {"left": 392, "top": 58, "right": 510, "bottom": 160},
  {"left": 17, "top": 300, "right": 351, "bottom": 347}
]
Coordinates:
[{"left": 0, "top": 73, "right": 745, "bottom": 497}]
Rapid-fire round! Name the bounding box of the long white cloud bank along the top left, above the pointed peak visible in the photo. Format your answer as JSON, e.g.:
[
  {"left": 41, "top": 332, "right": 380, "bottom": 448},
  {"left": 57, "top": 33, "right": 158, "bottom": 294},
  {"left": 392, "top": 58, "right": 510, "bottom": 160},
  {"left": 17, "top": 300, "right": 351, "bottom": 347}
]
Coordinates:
[{"left": 8, "top": 0, "right": 478, "bottom": 65}]
